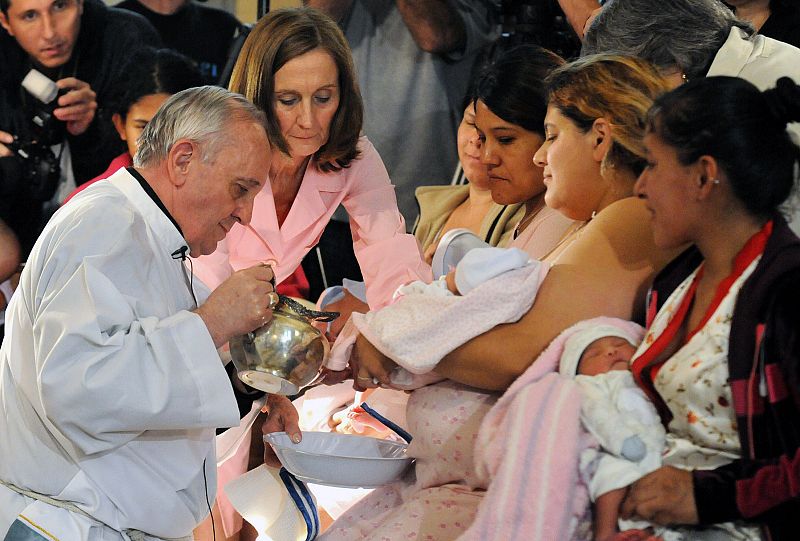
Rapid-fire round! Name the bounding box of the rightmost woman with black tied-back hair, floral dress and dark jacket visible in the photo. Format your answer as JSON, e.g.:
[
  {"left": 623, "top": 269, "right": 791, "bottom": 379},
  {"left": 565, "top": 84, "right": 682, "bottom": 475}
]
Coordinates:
[{"left": 622, "top": 77, "right": 800, "bottom": 540}]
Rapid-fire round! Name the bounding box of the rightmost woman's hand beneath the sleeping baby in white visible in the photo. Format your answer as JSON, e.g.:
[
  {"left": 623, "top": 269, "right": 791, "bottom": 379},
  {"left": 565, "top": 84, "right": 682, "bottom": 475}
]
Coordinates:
[{"left": 620, "top": 466, "right": 698, "bottom": 525}]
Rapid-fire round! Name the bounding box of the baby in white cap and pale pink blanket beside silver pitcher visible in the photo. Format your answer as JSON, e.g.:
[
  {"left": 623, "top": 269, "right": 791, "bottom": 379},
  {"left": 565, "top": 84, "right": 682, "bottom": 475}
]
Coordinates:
[{"left": 327, "top": 247, "right": 548, "bottom": 389}]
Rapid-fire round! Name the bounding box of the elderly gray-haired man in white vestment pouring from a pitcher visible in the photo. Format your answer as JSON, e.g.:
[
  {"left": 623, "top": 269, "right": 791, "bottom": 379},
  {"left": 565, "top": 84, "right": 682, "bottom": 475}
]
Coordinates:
[{"left": 0, "top": 87, "right": 300, "bottom": 541}]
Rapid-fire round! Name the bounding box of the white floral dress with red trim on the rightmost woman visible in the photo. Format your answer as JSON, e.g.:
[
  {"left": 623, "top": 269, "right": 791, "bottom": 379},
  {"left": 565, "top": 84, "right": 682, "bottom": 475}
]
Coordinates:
[{"left": 631, "top": 229, "right": 763, "bottom": 540}]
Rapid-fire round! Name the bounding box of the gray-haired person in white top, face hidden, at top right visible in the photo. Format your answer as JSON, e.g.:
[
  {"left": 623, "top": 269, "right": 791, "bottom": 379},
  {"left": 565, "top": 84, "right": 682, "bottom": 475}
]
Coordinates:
[{"left": 582, "top": 0, "right": 800, "bottom": 232}]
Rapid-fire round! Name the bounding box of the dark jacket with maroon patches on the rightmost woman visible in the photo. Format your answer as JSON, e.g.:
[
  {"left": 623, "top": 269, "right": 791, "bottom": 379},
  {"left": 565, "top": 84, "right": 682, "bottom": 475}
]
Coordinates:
[{"left": 649, "top": 216, "right": 800, "bottom": 541}]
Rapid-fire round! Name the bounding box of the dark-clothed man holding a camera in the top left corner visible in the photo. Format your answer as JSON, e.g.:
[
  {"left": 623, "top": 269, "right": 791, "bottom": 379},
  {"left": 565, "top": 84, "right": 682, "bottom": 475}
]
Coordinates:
[{"left": 0, "top": 0, "right": 160, "bottom": 258}]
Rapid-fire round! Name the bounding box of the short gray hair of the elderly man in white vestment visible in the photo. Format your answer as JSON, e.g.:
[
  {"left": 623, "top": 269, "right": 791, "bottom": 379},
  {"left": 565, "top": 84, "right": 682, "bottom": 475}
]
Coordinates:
[{"left": 133, "top": 86, "right": 266, "bottom": 167}]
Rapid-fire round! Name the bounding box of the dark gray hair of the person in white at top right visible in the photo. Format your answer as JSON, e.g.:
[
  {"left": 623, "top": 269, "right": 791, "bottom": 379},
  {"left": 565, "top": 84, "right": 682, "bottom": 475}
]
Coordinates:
[{"left": 581, "top": 0, "right": 755, "bottom": 79}]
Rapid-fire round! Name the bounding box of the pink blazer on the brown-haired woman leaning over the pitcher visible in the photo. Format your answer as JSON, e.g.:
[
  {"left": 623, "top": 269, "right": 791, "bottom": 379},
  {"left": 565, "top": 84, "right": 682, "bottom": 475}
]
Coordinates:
[{"left": 194, "top": 137, "right": 431, "bottom": 309}]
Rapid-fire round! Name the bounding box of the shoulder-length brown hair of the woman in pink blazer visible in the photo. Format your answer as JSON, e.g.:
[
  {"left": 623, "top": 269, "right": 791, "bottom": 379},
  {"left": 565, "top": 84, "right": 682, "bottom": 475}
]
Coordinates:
[{"left": 229, "top": 7, "right": 364, "bottom": 172}]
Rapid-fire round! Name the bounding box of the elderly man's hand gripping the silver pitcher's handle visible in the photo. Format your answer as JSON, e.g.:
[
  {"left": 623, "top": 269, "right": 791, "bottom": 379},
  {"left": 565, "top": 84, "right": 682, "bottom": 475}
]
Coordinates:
[{"left": 195, "top": 263, "right": 277, "bottom": 347}]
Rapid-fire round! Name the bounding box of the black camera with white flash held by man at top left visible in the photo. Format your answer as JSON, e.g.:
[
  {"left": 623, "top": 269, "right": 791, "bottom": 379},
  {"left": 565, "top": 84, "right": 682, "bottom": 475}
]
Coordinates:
[{"left": 6, "top": 70, "right": 66, "bottom": 201}]
